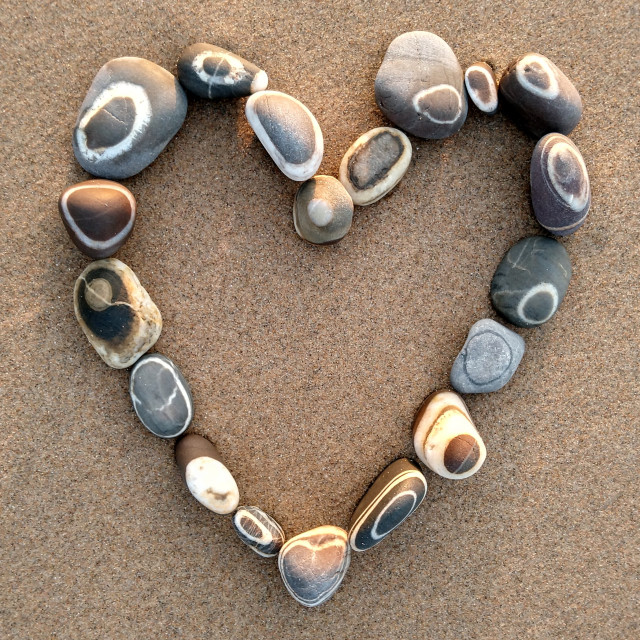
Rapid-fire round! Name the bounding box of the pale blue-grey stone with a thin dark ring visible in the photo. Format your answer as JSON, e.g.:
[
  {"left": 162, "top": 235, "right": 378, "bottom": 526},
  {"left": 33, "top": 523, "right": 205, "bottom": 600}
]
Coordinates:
[{"left": 450, "top": 318, "right": 524, "bottom": 393}]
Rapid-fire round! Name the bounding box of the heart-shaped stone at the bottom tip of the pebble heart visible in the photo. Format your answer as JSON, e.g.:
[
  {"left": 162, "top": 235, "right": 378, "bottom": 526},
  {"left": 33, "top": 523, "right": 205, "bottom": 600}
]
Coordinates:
[{"left": 278, "top": 525, "right": 351, "bottom": 607}]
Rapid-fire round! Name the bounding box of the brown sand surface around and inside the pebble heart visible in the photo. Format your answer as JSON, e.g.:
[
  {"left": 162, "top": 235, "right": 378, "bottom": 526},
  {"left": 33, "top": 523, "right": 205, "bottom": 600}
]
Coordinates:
[{"left": 0, "top": 0, "right": 640, "bottom": 640}]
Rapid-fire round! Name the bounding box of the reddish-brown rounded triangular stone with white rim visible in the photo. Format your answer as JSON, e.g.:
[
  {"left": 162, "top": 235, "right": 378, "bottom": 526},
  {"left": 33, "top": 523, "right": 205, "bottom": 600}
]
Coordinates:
[{"left": 58, "top": 180, "right": 136, "bottom": 258}]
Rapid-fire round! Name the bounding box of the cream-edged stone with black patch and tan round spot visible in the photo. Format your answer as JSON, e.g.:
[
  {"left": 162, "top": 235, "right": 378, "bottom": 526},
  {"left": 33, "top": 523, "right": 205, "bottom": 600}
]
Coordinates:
[{"left": 73, "top": 258, "right": 162, "bottom": 369}]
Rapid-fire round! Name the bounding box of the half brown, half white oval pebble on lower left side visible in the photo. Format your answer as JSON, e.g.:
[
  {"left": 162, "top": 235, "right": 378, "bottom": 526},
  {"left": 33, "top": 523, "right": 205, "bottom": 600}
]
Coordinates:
[{"left": 175, "top": 433, "right": 240, "bottom": 515}]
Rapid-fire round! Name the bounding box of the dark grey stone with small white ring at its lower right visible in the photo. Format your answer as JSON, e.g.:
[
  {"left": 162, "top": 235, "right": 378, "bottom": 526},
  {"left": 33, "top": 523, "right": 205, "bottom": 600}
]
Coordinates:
[{"left": 490, "top": 236, "right": 571, "bottom": 327}]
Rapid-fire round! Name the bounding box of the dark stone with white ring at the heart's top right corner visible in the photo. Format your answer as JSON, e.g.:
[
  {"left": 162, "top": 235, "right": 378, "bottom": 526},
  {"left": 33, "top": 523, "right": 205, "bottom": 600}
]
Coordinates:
[{"left": 499, "top": 53, "right": 582, "bottom": 138}]
